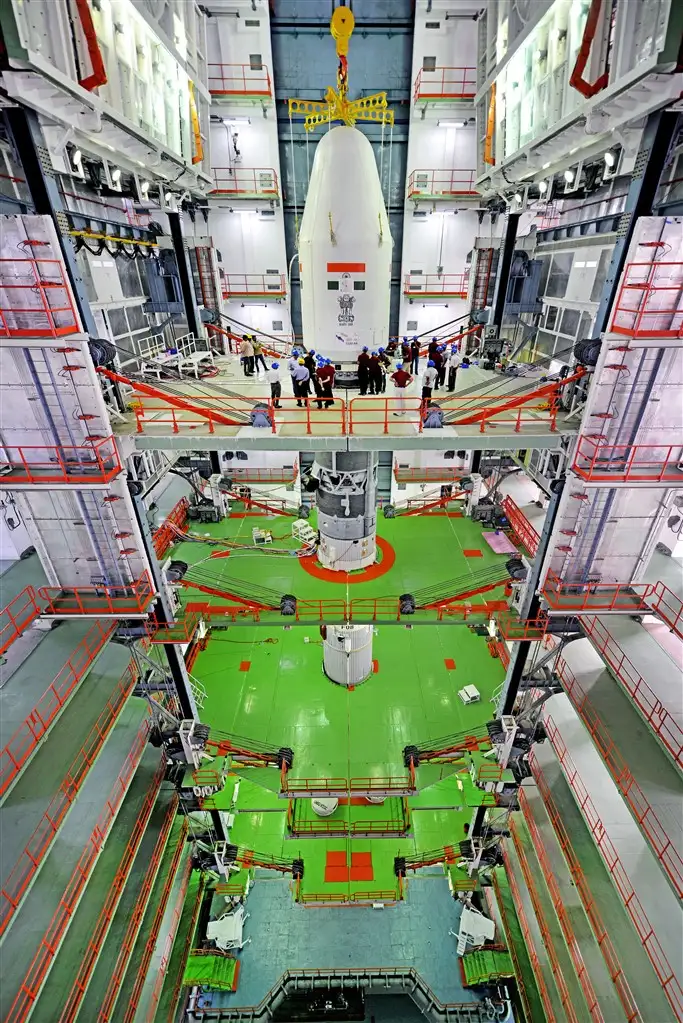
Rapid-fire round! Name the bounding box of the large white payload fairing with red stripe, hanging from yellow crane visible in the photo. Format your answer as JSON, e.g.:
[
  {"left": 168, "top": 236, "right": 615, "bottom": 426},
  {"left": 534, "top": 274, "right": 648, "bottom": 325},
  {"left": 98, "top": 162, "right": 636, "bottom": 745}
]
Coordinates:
[{"left": 299, "top": 126, "right": 393, "bottom": 365}]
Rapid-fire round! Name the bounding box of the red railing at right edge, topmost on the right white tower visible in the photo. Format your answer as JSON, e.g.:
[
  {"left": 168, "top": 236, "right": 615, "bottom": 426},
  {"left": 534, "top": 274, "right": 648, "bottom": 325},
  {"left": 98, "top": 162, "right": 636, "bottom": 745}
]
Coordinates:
[{"left": 610, "top": 257, "right": 683, "bottom": 338}]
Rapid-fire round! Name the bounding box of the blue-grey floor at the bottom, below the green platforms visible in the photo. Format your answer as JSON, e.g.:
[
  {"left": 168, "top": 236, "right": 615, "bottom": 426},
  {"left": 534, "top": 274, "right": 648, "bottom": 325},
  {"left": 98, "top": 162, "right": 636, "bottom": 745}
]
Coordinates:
[{"left": 202, "top": 873, "right": 477, "bottom": 1008}]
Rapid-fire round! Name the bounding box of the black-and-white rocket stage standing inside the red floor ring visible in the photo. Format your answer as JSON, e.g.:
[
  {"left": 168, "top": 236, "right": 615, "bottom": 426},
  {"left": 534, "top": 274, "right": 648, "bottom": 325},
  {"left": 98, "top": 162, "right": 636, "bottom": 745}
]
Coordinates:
[{"left": 314, "top": 451, "right": 377, "bottom": 572}]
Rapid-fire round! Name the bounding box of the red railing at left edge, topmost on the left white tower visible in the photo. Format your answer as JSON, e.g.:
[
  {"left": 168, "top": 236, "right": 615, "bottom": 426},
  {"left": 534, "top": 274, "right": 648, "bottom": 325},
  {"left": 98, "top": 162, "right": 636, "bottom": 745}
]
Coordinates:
[{"left": 0, "top": 257, "right": 81, "bottom": 338}]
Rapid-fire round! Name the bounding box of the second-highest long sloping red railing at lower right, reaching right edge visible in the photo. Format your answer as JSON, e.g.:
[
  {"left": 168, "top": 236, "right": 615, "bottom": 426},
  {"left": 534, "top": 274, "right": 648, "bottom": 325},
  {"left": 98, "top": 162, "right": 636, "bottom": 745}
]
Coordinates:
[{"left": 555, "top": 657, "right": 683, "bottom": 898}]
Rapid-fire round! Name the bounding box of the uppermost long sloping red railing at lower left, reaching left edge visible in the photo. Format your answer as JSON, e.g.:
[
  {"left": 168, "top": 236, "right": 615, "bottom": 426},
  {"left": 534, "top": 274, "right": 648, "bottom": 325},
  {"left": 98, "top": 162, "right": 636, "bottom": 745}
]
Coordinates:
[{"left": 0, "top": 622, "right": 115, "bottom": 796}]
